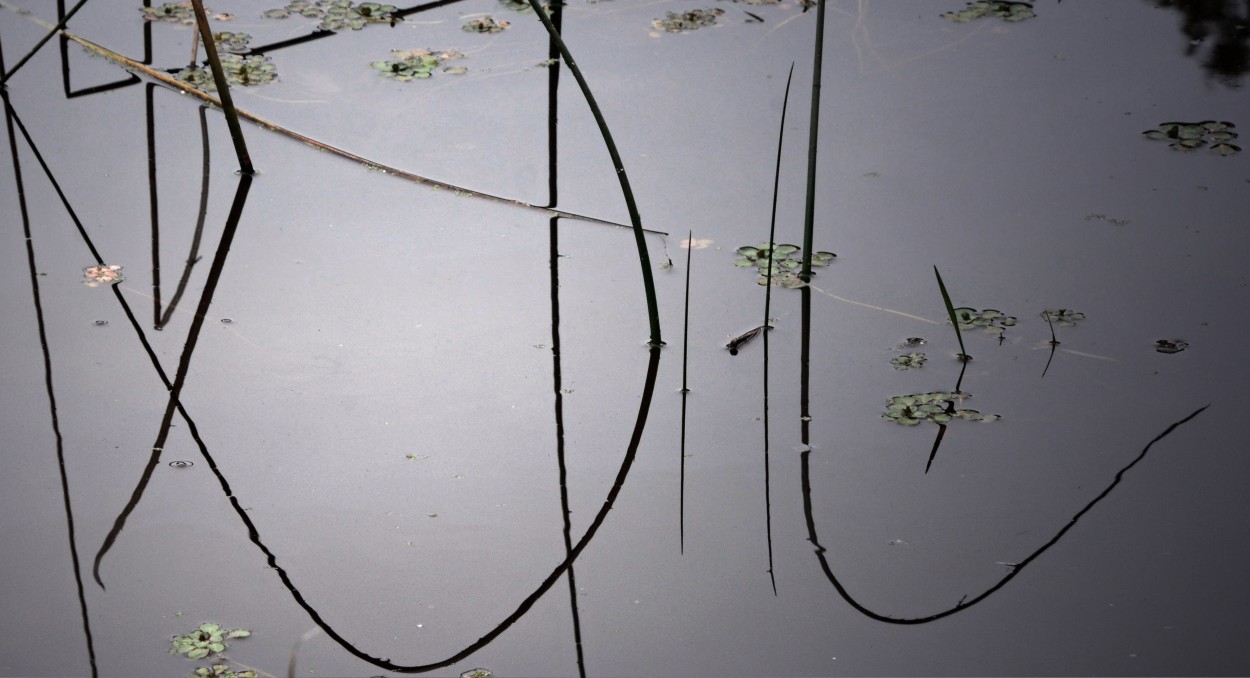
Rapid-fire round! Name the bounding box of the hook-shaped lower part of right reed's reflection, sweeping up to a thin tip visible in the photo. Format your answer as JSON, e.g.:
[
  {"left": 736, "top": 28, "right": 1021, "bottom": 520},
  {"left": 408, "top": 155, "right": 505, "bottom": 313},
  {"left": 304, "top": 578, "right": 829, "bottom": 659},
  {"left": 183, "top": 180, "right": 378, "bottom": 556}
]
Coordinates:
[{"left": 800, "top": 405, "right": 1210, "bottom": 624}]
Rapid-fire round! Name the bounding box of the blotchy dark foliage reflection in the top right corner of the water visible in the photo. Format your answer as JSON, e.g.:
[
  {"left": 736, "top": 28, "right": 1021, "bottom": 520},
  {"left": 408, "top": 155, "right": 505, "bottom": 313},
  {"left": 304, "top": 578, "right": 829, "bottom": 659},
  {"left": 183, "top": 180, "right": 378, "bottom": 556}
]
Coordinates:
[{"left": 1150, "top": 0, "right": 1250, "bottom": 89}]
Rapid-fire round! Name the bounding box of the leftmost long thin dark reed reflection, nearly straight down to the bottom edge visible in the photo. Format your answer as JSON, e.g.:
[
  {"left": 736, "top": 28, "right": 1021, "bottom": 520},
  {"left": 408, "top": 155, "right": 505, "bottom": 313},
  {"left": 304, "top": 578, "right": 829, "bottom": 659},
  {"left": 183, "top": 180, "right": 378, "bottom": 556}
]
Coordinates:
[{"left": 0, "top": 85, "right": 98, "bottom": 677}]
